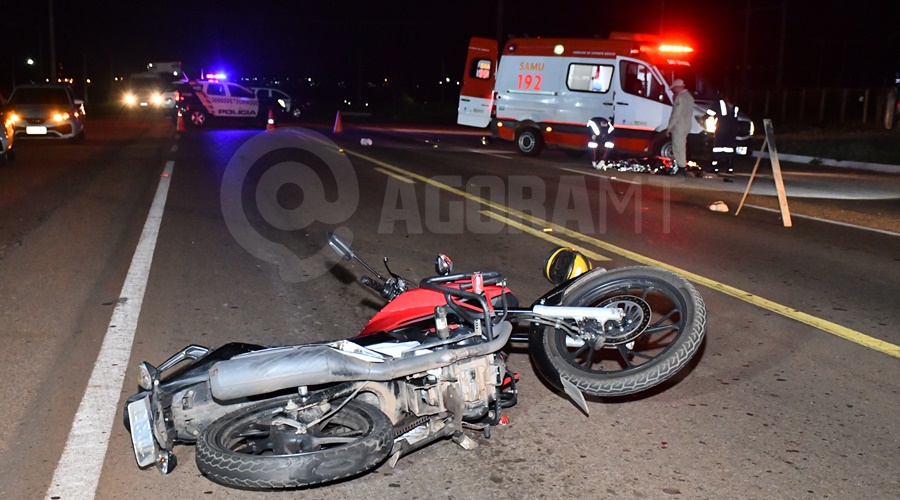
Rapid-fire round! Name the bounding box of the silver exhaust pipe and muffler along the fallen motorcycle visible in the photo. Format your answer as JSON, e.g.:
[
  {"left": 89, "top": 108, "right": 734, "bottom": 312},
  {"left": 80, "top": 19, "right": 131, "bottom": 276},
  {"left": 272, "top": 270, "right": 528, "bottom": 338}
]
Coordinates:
[{"left": 209, "top": 321, "right": 512, "bottom": 401}]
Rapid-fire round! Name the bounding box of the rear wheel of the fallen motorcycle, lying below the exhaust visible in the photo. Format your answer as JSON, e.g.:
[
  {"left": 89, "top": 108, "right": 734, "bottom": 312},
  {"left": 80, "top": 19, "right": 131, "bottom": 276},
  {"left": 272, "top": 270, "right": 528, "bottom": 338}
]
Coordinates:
[{"left": 197, "top": 396, "right": 394, "bottom": 489}]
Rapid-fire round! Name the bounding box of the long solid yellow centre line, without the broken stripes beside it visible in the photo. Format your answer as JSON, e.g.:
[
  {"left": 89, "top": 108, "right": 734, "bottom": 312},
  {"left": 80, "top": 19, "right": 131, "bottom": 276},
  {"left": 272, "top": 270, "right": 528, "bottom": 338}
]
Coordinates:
[{"left": 345, "top": 150, "right": 900, "bottom": 358}]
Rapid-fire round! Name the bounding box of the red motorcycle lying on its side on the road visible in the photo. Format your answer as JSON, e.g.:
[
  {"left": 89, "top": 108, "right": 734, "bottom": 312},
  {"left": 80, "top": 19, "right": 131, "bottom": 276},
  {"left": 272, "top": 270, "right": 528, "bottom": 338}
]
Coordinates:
[{"left": 124, "top": 235, "right": 706, "bottom": 489}]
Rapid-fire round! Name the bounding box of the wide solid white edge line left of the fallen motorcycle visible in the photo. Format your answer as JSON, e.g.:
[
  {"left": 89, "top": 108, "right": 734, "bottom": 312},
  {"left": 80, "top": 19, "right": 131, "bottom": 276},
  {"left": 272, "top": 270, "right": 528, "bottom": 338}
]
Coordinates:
[{"left": 46, "top": 161, "right": 175, "bottom": 500}]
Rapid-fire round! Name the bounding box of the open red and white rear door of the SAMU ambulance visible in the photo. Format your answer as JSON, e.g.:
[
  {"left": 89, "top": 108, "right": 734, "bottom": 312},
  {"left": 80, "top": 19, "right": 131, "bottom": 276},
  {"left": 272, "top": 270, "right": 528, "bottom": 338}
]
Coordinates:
[{"left": 456, "top": 37, "right": 498, "bottom": 128}]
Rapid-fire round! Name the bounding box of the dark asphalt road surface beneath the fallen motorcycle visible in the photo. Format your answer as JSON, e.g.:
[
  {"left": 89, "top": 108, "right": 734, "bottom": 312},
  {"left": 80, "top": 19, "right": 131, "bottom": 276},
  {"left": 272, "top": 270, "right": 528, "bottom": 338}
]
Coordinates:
[{"left": 0, "top": 116, "right": 900, "bottom": 498}]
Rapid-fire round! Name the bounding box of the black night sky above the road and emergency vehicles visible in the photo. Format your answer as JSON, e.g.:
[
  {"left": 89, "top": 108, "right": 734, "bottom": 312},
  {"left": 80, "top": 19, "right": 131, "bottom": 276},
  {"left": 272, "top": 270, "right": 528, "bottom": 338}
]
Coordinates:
[{"left": 0, "top": 0, "right": 900, "bottom": 97}]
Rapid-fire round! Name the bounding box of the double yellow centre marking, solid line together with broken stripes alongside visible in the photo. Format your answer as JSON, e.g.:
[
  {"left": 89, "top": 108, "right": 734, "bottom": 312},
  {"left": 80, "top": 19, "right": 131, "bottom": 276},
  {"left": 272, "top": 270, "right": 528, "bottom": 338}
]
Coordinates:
[{"left": 344, "top": 150, "right": 900, "bottom": 358}]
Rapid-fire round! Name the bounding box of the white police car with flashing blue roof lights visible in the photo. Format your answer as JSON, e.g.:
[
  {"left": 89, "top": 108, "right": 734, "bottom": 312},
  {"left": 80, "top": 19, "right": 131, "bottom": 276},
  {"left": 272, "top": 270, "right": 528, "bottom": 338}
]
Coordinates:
[{"left": 175, "top": 79, "right": 268, "bottom": 127}]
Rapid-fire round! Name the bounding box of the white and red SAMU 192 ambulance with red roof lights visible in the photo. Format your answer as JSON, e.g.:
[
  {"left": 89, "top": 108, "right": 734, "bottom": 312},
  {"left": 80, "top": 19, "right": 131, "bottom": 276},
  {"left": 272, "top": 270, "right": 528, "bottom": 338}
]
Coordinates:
[{"left": 457, "top": 32, "right": 753, "bottom": 160}]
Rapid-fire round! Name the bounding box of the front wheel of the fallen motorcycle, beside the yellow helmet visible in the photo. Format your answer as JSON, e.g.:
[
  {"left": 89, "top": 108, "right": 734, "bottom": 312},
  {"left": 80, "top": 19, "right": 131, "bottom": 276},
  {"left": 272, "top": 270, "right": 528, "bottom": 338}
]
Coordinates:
[{"left": 529, "top": 267, "right": 706, "bottom": 397}]
